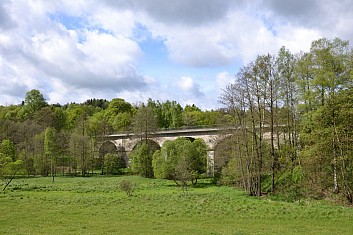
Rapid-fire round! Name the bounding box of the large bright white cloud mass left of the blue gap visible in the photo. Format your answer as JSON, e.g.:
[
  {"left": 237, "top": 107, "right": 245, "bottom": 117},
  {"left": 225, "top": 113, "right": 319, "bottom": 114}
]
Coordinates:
[{"left": 0, "top": 1, "right": 150, "bottom": 103}]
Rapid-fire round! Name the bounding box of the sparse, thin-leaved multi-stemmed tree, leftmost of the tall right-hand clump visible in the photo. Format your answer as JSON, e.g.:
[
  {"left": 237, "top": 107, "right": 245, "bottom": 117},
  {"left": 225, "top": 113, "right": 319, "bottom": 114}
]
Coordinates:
[{"left": 220, "top": 55, "right": 277, "bottom": 196}]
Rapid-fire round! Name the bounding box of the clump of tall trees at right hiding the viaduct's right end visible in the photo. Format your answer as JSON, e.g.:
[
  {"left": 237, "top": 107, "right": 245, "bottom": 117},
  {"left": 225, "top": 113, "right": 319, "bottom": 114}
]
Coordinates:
[{"left": 219, "top": 38, "right": 353, "bottom": 203}]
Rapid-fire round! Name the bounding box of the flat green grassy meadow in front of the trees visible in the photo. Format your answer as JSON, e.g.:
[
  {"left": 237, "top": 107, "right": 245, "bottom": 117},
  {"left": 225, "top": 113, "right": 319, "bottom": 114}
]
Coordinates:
[{"left": 0, "top": 176, "right": 353, "bottom": 234}]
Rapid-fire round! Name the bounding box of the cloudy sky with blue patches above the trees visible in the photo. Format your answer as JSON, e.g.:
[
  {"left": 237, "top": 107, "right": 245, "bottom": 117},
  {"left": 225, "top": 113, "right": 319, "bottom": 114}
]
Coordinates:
[{"left": 0, "top": 0, "right": 353, "bottom": 110}]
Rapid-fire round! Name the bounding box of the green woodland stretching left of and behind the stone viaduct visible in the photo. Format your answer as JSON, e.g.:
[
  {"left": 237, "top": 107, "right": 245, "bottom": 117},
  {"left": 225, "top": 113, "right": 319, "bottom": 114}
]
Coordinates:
[{"left": 0, "top": 90, "right": 229, "bottom": 180}]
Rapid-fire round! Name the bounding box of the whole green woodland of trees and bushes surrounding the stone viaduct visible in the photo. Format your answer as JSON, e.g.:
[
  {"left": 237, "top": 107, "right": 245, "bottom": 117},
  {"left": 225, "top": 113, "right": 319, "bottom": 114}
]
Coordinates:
[{"left": 0, "top": 38, "right": 353, "bottom": 203}]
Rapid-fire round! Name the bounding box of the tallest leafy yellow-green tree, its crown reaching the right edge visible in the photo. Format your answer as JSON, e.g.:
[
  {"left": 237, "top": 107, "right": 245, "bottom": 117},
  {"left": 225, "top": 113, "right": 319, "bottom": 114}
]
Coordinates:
[{"left": 298, "top": 38, "right": 351, "bottom": 193}]
